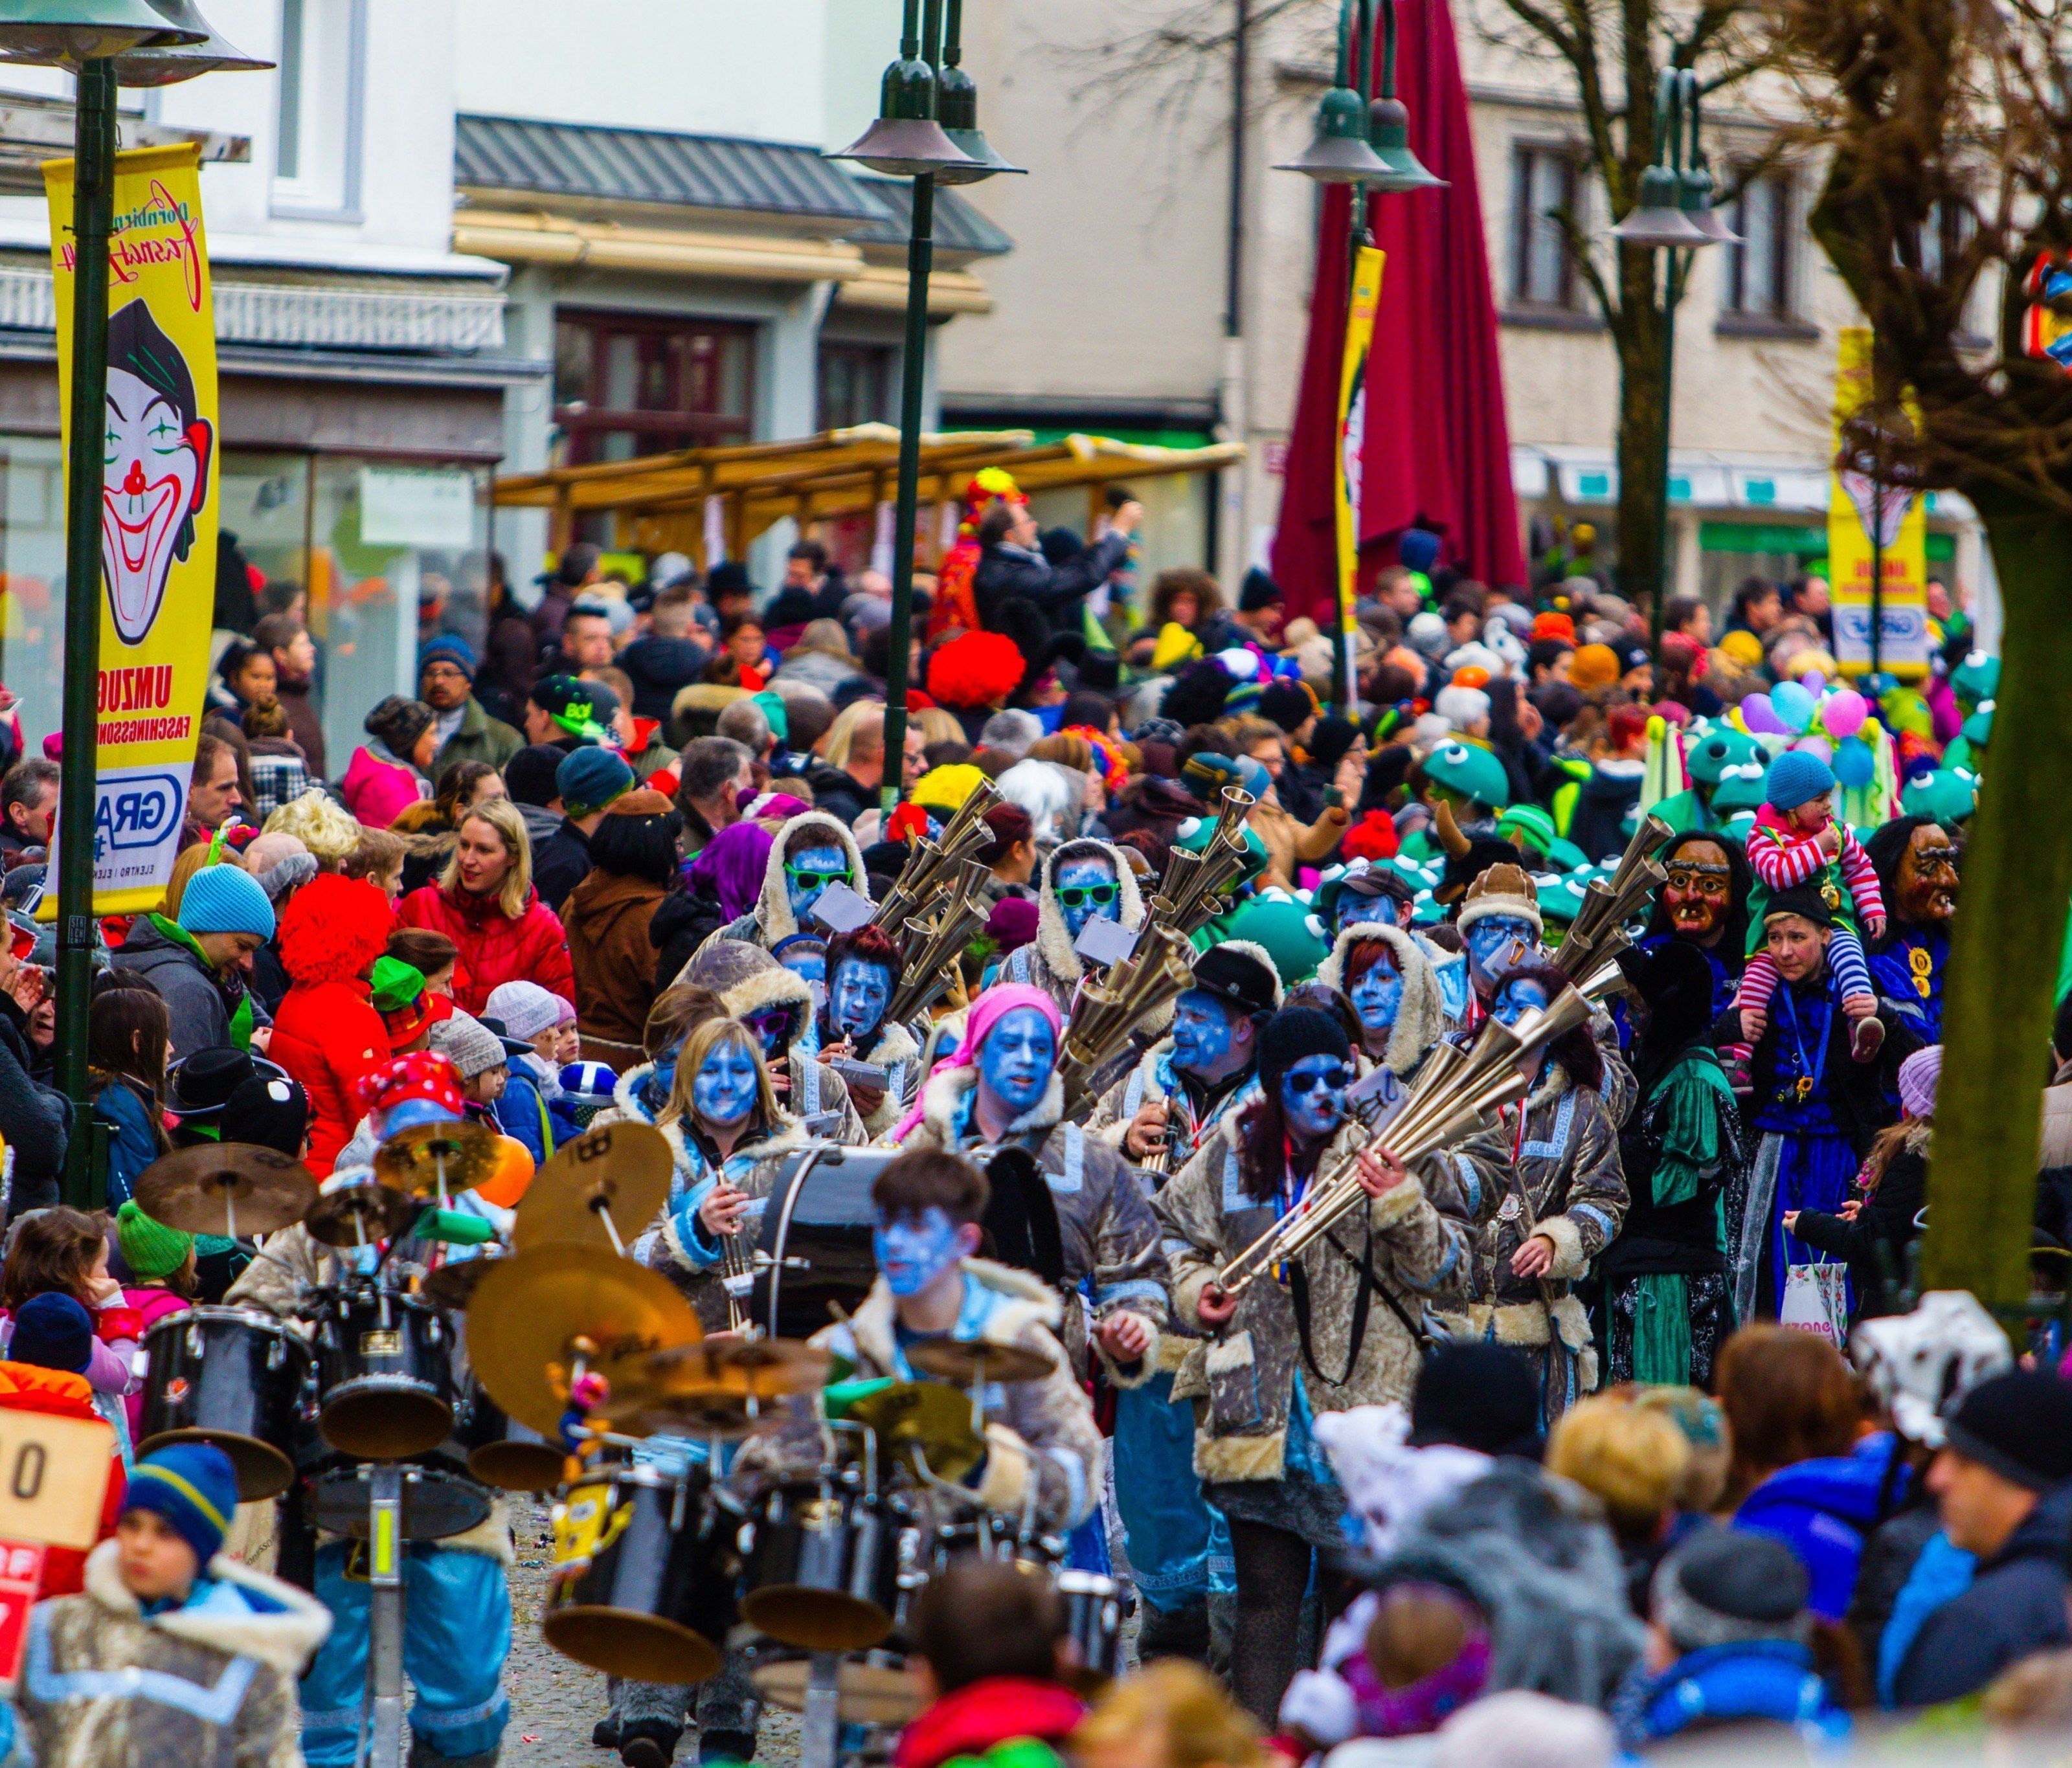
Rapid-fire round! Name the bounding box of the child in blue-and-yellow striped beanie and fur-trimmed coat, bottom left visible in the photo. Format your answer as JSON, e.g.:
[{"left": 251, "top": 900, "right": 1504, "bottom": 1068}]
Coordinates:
[{"left": 17, "top": 1442, "right": 332, "bottom": 1768}]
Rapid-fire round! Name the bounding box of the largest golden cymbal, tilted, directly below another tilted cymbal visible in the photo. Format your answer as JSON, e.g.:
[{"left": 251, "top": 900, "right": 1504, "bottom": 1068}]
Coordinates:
[{"left": 468, "top": 1246, "right": 703, "bottom": 1437}]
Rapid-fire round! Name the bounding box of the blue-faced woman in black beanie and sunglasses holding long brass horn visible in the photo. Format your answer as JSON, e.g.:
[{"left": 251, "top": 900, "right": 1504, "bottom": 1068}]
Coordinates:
[{"left": 1152, "top": 1007, "right": 1469, "bottom": 1723}]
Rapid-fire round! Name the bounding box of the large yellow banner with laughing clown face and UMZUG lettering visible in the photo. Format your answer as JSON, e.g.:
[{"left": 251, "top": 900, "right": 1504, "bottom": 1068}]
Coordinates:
[{"left": 43, "top": 145, "right": 221, "bottom": 914}]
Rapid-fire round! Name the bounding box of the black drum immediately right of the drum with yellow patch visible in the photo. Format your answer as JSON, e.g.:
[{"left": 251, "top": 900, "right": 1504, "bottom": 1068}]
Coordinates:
[{"left": 742, "top": 1480, "right": 899, "bottom": 1652}]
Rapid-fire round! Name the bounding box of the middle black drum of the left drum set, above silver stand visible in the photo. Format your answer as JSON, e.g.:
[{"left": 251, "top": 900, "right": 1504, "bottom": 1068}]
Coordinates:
[{"left": 317, "top": 1289, "right": 456, "bottom": 1461}]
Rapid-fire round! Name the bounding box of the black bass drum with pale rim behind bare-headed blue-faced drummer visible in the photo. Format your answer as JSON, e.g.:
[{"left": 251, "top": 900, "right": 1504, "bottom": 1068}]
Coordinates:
[{"left": 750, "top": 1142, "right": 897, "bottom": 1339}]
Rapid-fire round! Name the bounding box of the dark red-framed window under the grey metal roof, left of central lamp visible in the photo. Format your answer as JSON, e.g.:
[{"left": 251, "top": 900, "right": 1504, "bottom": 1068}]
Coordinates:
[{"left": 553, "top": 311, "right": 756, "bottom": 466}]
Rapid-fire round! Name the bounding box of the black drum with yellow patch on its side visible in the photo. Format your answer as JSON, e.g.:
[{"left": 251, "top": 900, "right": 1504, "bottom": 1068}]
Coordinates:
[{"left": 541, "top": 1468, "right": 744, "bottom": 1683}]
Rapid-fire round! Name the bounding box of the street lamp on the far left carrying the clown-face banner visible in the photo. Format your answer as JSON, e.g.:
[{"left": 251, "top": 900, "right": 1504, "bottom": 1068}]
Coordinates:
[{"left": 0, "top": 0, "right": 271, "bottom": 1206}]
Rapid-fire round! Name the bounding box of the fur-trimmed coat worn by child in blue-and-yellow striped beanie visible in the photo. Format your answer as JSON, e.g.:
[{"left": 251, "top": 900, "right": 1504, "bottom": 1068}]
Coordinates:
[{"left": 14, "top": 1540, "right": 332, "bottom": 1768}]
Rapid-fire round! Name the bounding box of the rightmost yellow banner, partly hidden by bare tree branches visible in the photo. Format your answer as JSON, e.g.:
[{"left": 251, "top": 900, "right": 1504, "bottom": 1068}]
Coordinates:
[{"left": 1827, "top": 326, "right": 1929, "bottom": 682}]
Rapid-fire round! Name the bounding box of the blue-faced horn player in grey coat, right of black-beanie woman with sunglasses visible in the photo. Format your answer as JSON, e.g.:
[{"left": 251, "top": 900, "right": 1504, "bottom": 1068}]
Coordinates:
[{"left": 1444, "top": 964, "right": 1627, "bottom": 1426}]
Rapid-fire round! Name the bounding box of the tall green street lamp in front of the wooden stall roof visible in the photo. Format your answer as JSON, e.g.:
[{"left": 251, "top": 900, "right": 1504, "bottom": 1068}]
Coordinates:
[{"left": 827, "top": 0, "right": 998, "bottom": 814}]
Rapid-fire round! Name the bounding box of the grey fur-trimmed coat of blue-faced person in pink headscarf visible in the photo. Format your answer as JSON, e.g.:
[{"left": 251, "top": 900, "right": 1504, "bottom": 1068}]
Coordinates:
[{"left": 899, "top": 1068, "right": 1167, "bottom": 1387}]
